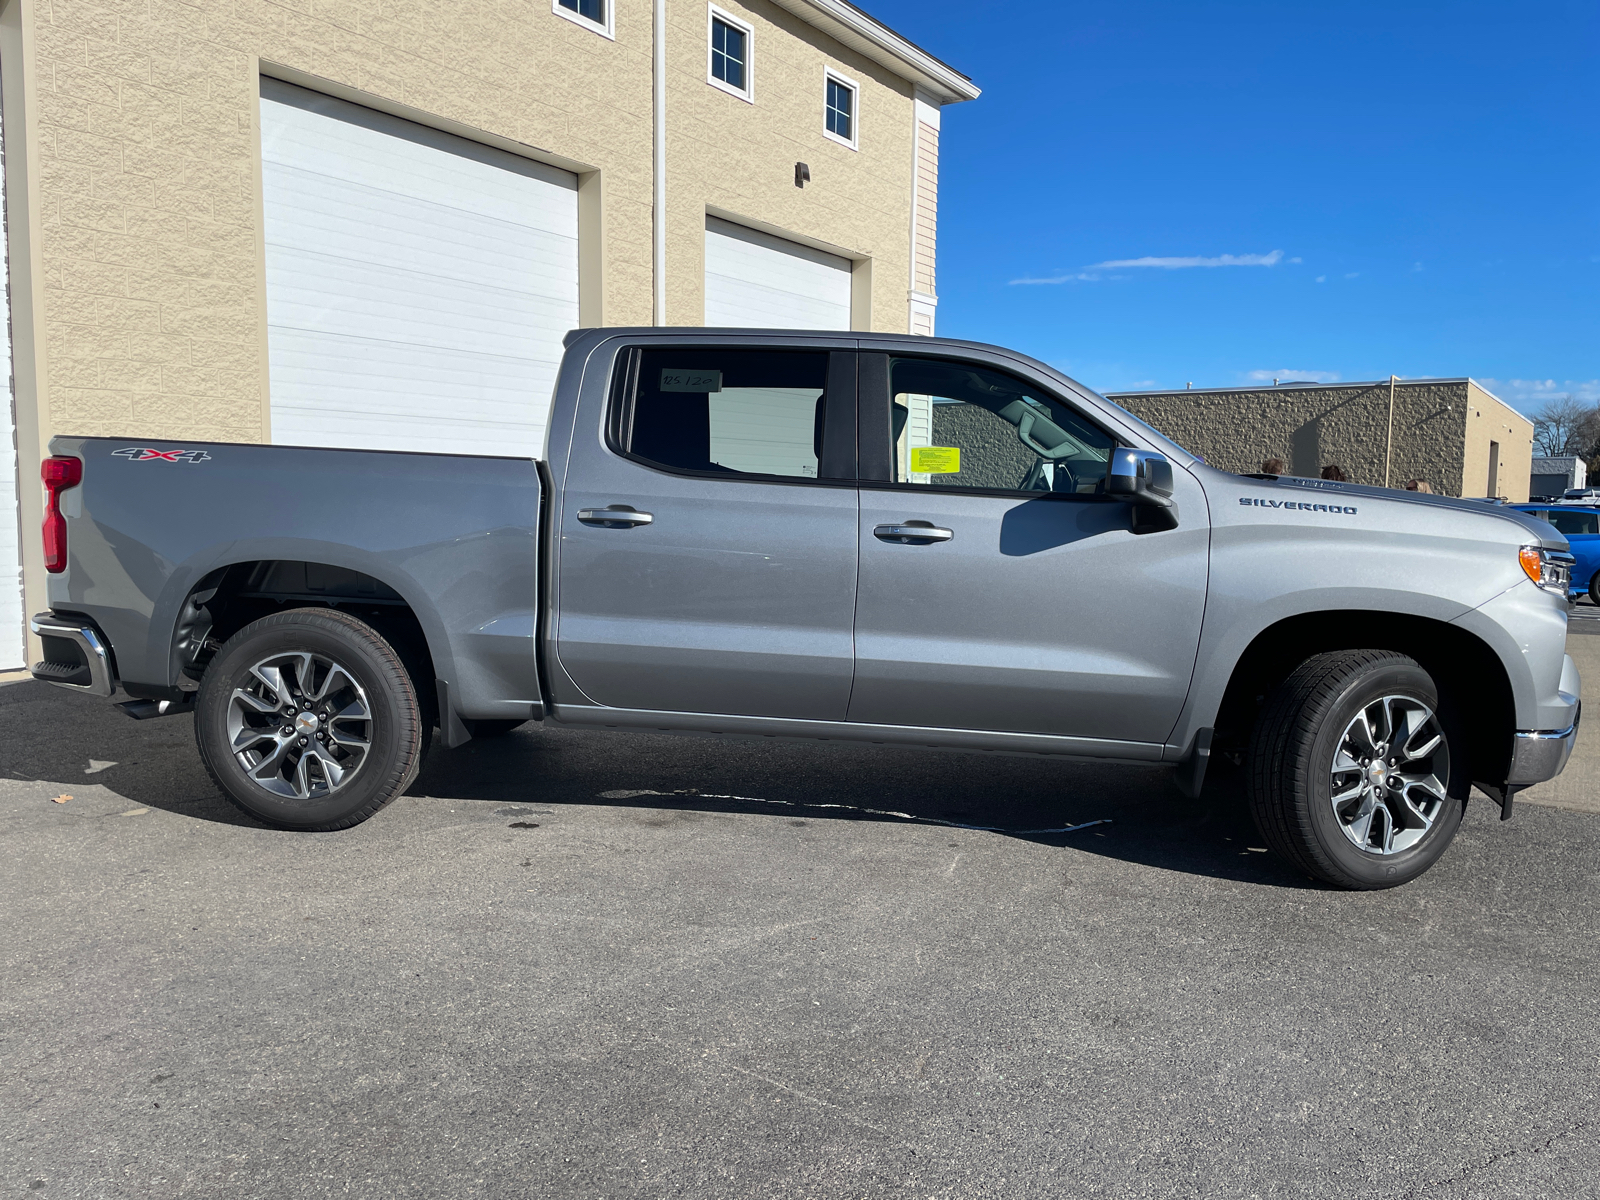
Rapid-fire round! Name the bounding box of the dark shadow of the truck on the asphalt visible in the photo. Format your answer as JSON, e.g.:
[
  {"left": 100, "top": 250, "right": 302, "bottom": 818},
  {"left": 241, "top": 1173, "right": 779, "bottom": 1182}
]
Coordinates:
[{"left": 0, "top": 682, "right": 1320, "bottom": 888}]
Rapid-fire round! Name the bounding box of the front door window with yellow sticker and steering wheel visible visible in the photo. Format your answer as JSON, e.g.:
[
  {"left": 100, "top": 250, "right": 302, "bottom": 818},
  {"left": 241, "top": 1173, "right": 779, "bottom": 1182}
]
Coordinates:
[{"left": 890, "top": 358, "right": 1117, "bottom": 494}]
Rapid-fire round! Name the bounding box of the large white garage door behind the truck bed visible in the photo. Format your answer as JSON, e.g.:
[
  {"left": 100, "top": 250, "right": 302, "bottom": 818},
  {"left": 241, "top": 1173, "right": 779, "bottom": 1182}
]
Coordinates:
[{"left": 261, "top": 80, "right": 578, "bottom": 458}]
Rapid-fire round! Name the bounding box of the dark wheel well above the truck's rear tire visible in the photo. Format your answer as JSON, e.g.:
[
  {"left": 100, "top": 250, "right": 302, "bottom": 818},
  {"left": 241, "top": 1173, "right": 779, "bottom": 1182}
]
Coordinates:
[{"left": 173, "top": 558, "right": 438, "bottom": 720}]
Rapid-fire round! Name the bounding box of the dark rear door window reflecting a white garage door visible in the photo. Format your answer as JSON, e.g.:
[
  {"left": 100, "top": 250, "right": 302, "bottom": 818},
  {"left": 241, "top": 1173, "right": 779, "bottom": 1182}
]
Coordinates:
[{"left": 621, "top": 349, "right": 829, "bottom": 478}]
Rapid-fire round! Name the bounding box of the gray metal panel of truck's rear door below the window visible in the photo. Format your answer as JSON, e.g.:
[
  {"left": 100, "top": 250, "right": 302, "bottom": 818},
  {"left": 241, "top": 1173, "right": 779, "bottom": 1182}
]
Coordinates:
[{"left": 555, "top": 460, "right": 856, "bottom": 720}]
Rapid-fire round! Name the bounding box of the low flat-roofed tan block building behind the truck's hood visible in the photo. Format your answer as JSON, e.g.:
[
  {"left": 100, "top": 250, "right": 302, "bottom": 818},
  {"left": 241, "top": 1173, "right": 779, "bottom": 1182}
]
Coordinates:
[{"left": 1110, "top": 379, "right": 1533, "bottom": 501}]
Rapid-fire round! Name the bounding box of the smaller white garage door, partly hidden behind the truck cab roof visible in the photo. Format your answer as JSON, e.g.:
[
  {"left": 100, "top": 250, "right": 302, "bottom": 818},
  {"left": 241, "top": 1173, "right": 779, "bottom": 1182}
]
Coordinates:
[{"left": 706, "top": 216, "right": 850, "bottom": 330}]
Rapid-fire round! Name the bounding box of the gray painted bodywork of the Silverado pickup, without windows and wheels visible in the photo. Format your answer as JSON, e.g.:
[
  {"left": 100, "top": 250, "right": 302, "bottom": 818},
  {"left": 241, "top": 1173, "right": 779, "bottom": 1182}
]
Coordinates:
[{"left": 50, "top": 330, "right": 1576, "bottom": 790}]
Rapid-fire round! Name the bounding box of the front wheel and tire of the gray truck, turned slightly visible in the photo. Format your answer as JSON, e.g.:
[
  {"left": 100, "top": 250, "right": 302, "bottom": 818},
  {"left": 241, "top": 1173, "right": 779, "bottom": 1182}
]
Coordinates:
[{"left": 1245, "top": 650, "right": 1470, "bottom": 890}]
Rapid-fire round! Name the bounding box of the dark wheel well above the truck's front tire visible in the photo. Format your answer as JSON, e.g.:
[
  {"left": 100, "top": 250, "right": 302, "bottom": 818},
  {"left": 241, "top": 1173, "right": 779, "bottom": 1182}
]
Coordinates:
[{"left": 1214, "top": 611, "right": 1515, "bottom": 784}]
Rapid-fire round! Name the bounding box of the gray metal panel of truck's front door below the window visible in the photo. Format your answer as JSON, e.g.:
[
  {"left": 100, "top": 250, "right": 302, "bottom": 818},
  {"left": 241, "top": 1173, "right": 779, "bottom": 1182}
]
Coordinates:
[{"left": 850, "top": 469, "right": 1208, "bottom": 744}]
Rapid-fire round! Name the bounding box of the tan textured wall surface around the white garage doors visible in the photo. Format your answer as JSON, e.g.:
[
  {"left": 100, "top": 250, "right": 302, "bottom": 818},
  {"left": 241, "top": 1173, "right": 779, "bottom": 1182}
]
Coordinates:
[{"left": 0, "top": 0, "right": 976, "bottom": 662}]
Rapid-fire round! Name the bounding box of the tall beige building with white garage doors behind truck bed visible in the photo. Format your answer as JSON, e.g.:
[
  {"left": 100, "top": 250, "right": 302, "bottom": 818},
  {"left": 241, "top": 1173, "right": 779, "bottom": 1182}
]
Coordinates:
[{"left": 0, "top": 0, "right": 978, "bottom": 670}]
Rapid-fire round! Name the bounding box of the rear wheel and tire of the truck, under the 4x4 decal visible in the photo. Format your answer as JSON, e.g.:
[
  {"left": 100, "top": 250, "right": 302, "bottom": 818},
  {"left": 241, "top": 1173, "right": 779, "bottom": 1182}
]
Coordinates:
[{"left": 195, "top": 608, "right": 430, "bottom": 830}]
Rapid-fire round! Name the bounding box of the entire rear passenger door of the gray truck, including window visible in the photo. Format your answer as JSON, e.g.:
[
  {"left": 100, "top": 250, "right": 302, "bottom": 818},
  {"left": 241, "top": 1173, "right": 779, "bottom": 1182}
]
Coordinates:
[{"left": 557, "top": 347, "right": 859, "bottom": 720}]
